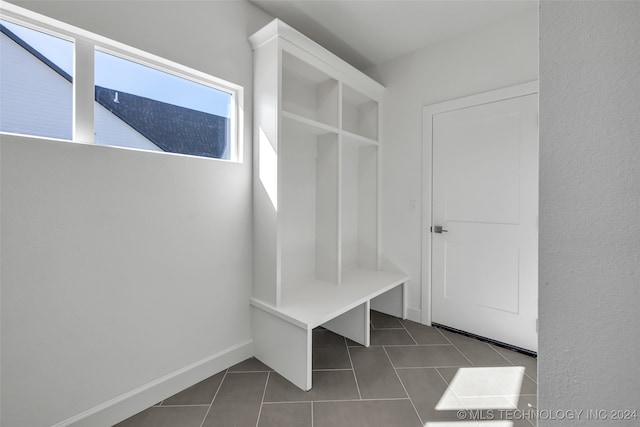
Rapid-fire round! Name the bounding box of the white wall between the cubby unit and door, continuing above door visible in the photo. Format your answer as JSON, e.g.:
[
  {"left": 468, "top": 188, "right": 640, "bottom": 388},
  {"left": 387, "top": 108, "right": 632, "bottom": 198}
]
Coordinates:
[{"left": 368, "top": 8, "right": 538, "bottom": 320}]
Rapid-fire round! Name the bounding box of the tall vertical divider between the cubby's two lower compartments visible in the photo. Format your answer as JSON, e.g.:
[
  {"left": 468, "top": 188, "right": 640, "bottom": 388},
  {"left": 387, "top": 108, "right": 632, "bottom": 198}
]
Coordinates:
[{"left": 316, "top": 133, "right": 340, "bottom": 285}]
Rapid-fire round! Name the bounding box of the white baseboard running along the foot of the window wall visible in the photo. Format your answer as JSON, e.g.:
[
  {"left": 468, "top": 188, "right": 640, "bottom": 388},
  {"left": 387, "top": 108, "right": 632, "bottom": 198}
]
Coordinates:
[{"left": 52, "top": 340, "right": 253, "bottom": 427}]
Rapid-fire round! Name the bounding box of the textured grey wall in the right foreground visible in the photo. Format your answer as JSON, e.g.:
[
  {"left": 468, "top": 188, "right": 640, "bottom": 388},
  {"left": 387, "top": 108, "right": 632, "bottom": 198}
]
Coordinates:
[{"left": 538, "top": 1, "right": 640, "bottom": 426}]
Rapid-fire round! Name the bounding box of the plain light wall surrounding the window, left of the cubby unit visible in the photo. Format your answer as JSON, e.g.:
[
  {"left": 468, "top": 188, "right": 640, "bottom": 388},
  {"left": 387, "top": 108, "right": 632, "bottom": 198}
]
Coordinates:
[{"left": 0, "top": 1, "right": 270, "bottom": 427}]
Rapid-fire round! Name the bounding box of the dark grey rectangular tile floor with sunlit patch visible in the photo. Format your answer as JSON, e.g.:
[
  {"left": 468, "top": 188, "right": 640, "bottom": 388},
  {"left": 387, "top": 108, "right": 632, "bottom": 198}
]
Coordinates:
[{"left": 117, "top": 311, "right": 537, "bottom": 427}]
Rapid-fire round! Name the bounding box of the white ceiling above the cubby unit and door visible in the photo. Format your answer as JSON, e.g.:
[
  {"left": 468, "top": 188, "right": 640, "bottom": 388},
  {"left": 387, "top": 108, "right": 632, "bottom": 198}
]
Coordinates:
[{"left": 249, "top": 0, "right": 537, "bottom": 70}]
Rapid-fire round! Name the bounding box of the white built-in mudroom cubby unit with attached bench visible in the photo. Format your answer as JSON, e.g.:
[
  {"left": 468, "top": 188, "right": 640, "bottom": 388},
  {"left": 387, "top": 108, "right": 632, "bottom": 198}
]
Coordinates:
[{"left": 250, "top": 19, "right": 408, "bottom": 390}]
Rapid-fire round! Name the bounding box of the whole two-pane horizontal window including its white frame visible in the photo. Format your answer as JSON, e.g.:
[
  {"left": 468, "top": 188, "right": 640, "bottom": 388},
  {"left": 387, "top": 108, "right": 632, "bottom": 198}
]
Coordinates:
[{"left": 0, "top": 3, "right": 242, "bottom": 161}]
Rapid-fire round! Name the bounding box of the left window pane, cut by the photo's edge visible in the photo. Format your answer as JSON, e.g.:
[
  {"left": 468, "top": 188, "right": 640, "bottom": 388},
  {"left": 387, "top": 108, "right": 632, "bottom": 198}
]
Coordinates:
[{"left": 0, "top": 20, "right": 73, "bottom": 140}]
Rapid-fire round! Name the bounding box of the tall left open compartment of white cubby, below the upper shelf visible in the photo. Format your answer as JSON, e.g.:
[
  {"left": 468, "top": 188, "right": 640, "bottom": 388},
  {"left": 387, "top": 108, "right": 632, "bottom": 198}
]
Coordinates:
[{"left": 279, "top": 120, "right": 340, "bottom": 288}]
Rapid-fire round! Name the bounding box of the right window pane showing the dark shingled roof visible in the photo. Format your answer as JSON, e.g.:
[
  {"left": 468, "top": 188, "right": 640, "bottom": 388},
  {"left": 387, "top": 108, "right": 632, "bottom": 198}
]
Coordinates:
[{"left": 94, "top": 50, "right": 232, "bottom": 160}]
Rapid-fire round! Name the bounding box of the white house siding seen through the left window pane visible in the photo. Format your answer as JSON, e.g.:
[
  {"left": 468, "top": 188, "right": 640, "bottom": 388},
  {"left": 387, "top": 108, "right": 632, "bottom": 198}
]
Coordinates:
[{"left": 0, "top": 33, "right": 73, "bottom": 139}]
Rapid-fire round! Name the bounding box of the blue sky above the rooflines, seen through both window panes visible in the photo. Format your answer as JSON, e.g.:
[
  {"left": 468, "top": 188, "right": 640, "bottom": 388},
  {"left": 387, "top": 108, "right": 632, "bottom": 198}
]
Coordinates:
[{"left": 1, "top": 21, "right": 232, "bottom": 117}]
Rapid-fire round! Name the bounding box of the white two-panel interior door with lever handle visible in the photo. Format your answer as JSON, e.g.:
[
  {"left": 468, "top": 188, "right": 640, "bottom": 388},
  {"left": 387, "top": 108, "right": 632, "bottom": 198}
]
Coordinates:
[{"left": 430, "top": 88, "right": 538, "bottom": 351}]
